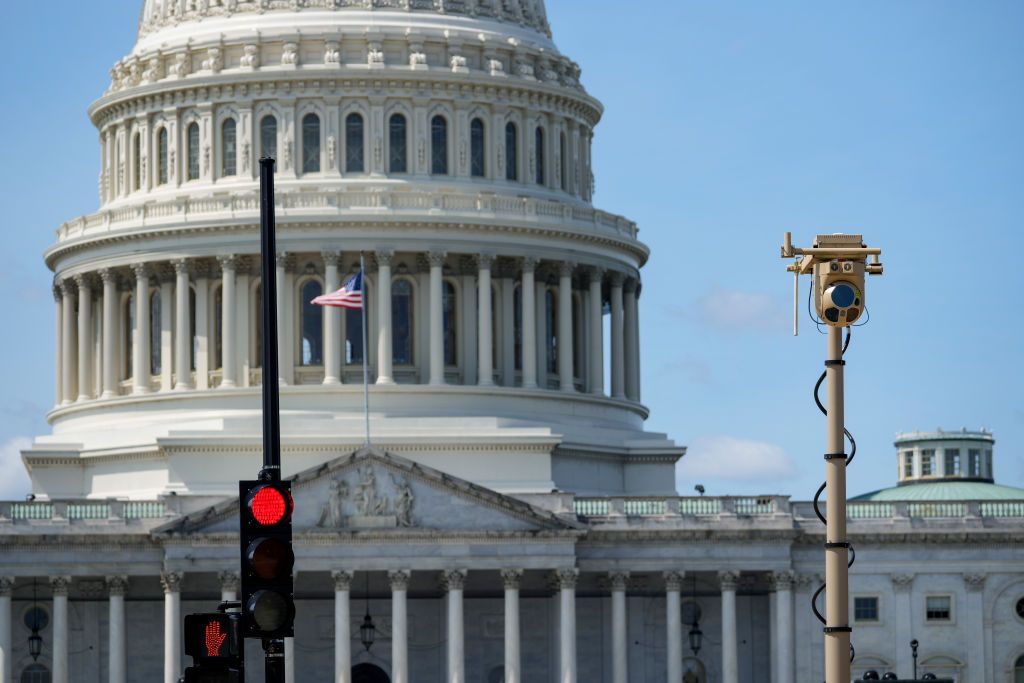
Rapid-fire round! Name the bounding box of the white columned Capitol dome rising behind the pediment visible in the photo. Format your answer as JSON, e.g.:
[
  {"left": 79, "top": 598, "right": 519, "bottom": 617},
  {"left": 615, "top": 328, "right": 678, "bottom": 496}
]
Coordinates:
[{"left": 24, "top": 0, "right": 683, "bottom": 504}]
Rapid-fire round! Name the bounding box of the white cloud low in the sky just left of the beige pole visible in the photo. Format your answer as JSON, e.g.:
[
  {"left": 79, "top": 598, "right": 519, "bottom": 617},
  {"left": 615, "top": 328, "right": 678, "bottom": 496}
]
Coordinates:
[{"left": 676, "top": 436, "right": 797, "bottom": 484}]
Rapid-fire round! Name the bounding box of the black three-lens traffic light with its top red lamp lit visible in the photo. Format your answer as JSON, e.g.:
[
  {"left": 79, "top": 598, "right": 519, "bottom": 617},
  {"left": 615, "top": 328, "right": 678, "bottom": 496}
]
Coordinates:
[{"left": 239, "top": 481, "right": 295, "bottom": 638}]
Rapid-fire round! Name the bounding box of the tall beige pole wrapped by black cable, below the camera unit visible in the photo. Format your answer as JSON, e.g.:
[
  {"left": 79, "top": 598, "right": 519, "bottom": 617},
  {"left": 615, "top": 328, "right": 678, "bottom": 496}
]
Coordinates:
[{"left": 825, "top": 326, "right": 850, "bottom": 683}]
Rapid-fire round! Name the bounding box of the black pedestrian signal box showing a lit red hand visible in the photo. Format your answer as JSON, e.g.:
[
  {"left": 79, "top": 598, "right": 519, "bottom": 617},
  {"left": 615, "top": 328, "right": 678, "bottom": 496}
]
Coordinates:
[{"left": 184, "top": 612, "right": 245, "bottom": 683}]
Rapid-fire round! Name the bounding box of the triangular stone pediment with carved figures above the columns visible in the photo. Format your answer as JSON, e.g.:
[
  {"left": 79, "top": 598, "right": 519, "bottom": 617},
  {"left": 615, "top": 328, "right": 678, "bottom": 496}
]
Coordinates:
[{"left": 155, "top": 447, "right": 582, "bottom": 537}]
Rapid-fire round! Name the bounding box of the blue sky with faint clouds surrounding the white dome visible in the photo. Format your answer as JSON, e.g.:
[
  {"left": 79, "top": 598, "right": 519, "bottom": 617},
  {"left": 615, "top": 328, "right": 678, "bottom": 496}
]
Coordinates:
[{"left": 0, "top": 0, "right": 1024, "bottom": 499}]
